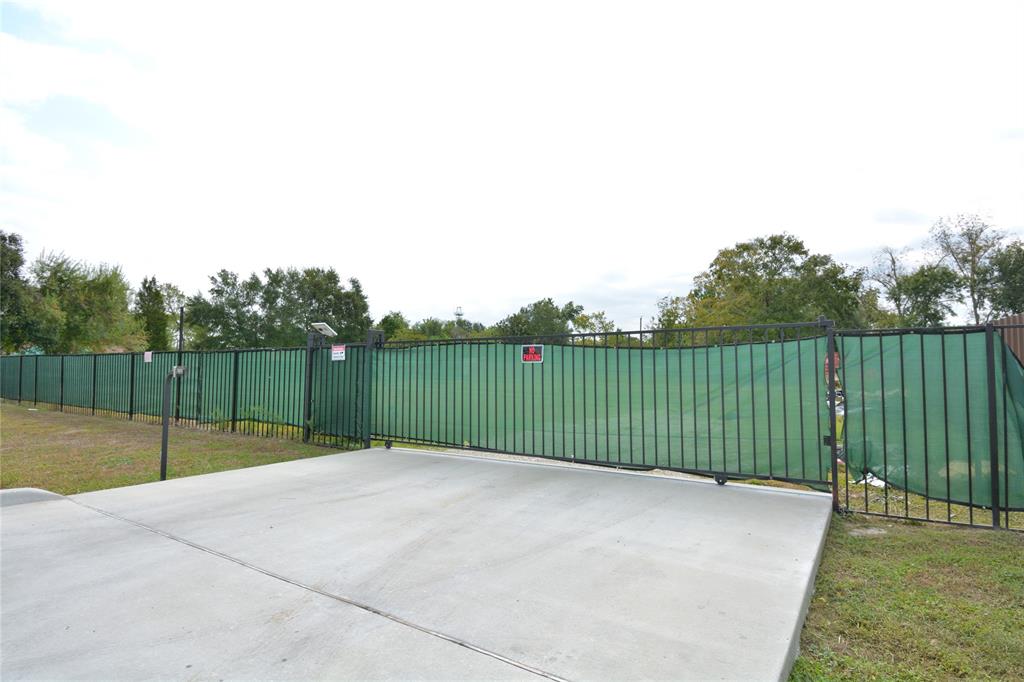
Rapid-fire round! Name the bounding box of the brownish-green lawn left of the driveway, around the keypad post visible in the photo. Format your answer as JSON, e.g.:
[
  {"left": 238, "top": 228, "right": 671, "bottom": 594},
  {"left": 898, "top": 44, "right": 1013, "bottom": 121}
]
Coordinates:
[{"left": 0, "top": 402, "right": 348, "bottom": 495}]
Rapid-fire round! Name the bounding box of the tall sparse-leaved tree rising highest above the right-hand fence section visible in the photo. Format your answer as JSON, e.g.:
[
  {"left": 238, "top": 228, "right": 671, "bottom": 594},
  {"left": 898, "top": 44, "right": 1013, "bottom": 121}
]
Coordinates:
[{"left": 931, "top": 215, "right": 1004, "bottom": 325}]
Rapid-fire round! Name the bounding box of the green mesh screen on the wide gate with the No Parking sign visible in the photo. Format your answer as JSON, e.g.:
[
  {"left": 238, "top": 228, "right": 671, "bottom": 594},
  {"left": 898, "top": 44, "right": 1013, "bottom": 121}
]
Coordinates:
[{"left": 373, "top": 337, "right": 829, "bottom": 482}]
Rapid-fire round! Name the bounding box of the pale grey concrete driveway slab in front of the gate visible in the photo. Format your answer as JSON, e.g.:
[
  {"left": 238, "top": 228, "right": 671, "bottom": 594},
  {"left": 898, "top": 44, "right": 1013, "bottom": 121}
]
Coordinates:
[{"left": 0, "top": 450, "right": 830, "bottom": 679}]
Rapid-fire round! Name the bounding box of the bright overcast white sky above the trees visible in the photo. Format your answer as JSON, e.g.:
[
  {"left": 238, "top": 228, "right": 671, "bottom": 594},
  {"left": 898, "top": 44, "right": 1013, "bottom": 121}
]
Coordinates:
[{"left": 0, "top": 0, "right": 1024, "bottom": 329}]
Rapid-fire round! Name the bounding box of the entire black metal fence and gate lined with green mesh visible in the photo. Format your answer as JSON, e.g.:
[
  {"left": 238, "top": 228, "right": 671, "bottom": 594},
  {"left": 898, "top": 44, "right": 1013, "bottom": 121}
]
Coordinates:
[{"left": 0, "top": 319, "right": 1024, "bottom": 529}]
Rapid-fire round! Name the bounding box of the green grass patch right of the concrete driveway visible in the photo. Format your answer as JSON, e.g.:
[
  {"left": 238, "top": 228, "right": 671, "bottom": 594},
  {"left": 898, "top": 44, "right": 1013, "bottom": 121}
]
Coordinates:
[{"left": 790, "top": 515, "right": 1024, "bottom": 680}]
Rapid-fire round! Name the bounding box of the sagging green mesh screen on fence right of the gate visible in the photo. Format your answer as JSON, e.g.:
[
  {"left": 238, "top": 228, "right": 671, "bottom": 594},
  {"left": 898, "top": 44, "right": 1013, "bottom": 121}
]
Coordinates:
[{"left": 838, "top": 331, "right": 1024, "bottom": 510}]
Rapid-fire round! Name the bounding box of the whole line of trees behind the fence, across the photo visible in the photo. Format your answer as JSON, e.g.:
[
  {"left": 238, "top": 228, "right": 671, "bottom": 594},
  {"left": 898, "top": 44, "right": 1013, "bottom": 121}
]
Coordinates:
[{"left": 0, "top": 215, "right": 1024, "bottom": 353}]
